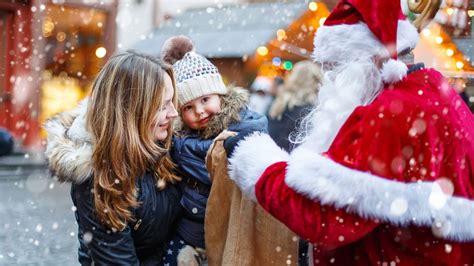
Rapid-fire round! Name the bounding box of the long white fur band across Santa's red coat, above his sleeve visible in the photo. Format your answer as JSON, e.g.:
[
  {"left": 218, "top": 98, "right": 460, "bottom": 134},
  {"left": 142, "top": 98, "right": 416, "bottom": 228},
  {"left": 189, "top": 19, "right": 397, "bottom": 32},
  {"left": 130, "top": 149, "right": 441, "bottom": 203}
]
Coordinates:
[{"left": 285, "top": 147, "right": 474, "bottom": 241}]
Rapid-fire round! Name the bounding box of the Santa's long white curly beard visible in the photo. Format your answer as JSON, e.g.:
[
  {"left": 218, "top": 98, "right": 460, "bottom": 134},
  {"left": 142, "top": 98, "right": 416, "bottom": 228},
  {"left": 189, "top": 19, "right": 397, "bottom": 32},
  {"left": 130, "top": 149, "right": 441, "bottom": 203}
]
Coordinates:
[{"left": 293, "top": 58, "right": 383, "bottom": 153}]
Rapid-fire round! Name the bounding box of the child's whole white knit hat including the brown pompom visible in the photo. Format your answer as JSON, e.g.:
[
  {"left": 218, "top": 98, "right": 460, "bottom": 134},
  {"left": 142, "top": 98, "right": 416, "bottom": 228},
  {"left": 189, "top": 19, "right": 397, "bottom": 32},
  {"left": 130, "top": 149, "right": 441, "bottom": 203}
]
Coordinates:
[{"left": 161, "top": 35, "right": 227, "bottom": 106}]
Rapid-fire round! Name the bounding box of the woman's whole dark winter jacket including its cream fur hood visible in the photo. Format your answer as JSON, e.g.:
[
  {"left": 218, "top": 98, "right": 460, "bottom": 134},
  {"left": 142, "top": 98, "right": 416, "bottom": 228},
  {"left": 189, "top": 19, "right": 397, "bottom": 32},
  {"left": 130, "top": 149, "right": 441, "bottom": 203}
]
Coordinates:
[{"left": 45, "top": 100, "right": 181, "bottom": 265}]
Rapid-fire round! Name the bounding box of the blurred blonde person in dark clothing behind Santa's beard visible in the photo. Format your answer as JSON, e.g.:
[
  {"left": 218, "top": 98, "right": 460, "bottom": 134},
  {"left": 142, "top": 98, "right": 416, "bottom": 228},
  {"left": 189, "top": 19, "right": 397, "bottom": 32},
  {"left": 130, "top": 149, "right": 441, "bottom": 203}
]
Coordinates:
[{"left": 268, "top": 60, "right": 322, "bottom": 151}]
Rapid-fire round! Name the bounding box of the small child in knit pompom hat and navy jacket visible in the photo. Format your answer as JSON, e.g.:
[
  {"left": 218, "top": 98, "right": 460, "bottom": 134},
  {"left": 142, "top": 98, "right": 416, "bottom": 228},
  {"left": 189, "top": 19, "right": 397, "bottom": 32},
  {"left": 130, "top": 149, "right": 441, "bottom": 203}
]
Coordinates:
[{"left": 162, "top": 36, "right": 267, "bottom": 265}]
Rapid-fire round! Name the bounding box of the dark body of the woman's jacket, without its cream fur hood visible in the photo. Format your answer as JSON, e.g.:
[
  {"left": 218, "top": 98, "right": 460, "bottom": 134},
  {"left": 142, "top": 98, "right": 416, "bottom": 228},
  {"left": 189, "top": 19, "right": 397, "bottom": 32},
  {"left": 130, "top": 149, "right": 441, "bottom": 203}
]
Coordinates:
[{"left": 71, "top": 174, "right": 181, "bottom": 265}]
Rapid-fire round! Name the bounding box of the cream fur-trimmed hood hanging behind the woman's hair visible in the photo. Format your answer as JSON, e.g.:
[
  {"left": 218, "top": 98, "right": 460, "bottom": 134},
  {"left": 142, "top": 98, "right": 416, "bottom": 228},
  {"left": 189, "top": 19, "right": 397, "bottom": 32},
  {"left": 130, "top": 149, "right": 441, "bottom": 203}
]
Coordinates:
[{"left": 44, "top": 100, "right": 92, "bottom": 184}]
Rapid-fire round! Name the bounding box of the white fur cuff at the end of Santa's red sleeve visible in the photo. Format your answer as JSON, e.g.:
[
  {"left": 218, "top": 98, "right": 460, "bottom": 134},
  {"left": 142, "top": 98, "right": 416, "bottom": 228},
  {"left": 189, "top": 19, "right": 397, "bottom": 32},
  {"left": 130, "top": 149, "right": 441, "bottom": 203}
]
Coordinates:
[{"left": 229, "top": 133, "right": 288, "bottom": 201}]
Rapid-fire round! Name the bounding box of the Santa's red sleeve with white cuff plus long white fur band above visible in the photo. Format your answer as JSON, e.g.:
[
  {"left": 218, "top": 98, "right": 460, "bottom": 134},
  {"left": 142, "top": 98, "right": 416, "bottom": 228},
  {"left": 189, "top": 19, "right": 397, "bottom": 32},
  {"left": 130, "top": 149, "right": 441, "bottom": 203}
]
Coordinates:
[{"left": 229, "top": 134, "right": 474, "bottom": 245}]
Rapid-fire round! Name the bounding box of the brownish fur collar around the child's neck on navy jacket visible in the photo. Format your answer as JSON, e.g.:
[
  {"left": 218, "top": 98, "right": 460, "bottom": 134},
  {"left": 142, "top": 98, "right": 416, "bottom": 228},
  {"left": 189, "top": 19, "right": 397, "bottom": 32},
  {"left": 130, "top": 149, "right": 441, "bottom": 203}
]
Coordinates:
[{"left": 175, "top": 88, "right": 249, "bottom": 139}]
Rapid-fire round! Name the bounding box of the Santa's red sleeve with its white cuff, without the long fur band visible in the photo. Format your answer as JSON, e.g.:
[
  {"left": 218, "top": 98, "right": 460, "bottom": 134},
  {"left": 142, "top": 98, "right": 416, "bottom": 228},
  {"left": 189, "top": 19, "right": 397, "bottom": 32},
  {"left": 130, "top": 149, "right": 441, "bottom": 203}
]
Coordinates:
[{"left": 229, "top": 134, "right": 377, "bottom": 248}]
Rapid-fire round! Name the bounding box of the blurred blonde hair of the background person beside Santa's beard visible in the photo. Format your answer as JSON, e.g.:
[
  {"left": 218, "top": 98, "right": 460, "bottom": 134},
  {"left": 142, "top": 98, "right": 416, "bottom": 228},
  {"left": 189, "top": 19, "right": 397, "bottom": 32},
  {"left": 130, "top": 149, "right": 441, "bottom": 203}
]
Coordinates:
[{"left": 269, "top": 60, "right": 322, "bottom": 119}]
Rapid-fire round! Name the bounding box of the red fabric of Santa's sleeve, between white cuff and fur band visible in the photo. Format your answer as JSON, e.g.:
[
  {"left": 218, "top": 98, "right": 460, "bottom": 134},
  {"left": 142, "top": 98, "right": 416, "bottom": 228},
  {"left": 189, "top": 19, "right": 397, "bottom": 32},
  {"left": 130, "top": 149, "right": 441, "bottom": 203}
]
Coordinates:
[{"left": 255, "top": 162, "right": 377, "bottom": 250}]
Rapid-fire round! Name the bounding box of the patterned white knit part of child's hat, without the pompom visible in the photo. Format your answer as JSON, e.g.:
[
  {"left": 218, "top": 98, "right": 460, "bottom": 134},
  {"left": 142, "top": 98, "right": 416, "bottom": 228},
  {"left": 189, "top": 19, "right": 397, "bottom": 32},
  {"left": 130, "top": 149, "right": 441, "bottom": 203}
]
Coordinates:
[{"left": 173, "top": 51, "right": 227, "bottom": 106}]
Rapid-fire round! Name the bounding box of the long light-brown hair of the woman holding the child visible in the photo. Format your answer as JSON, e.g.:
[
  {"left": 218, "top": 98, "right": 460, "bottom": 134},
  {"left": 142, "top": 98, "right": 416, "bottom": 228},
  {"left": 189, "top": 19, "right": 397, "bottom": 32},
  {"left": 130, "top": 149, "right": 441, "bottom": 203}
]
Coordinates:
[{"left": 86, "top": 51, "right": 179, "bottom": 231}]
